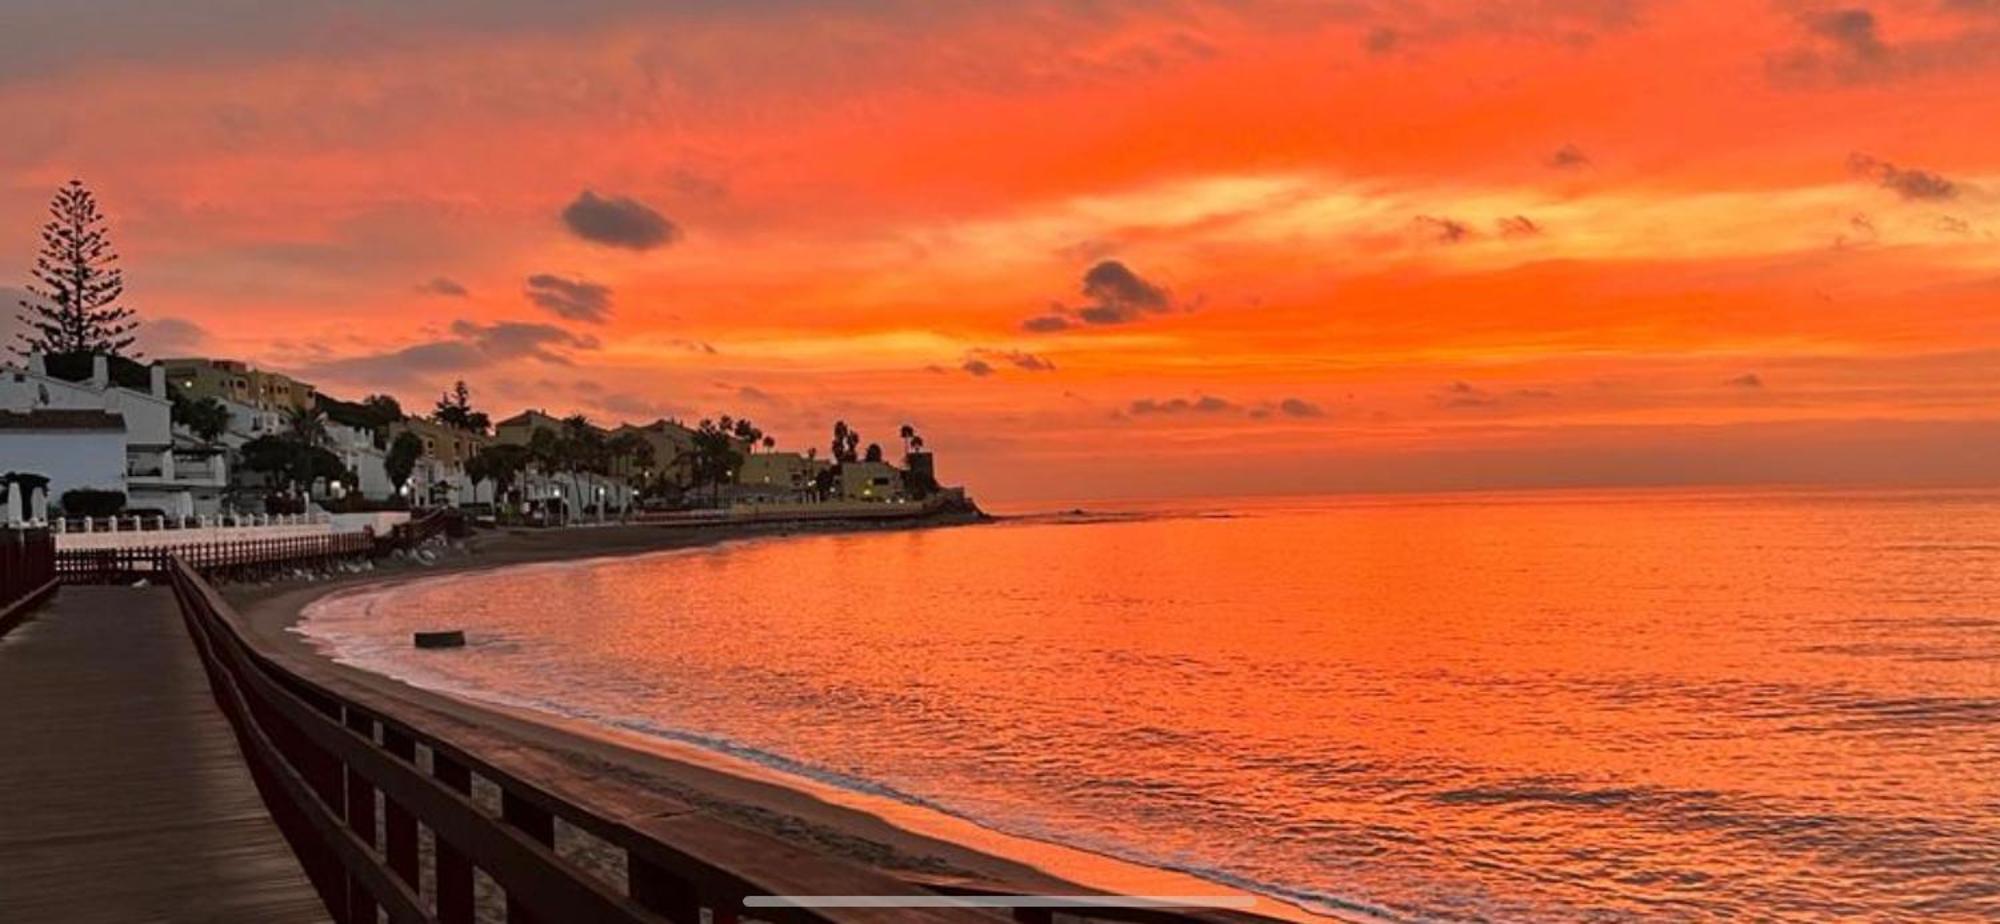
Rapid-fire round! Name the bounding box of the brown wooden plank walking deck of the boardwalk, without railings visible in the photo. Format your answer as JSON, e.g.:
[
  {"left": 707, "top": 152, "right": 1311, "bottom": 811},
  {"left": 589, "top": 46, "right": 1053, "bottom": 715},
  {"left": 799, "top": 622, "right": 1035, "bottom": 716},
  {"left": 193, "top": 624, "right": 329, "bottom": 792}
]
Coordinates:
[{"left": 0, "top": 586, "right": 326, "bottom": 924}]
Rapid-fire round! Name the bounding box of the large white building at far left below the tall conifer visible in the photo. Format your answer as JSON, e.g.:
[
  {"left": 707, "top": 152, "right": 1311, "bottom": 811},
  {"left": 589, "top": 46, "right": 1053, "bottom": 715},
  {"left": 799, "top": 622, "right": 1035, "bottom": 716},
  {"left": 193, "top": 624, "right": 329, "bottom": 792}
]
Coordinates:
[{"left": 0, "top": 356, "right": 228, "bottom": 516}]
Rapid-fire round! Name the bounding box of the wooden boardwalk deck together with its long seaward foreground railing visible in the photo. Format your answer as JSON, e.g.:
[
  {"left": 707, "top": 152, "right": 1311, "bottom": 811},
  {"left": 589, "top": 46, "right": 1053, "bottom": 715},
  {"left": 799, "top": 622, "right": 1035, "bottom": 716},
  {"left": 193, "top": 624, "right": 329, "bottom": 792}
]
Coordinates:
[{"left": 0, "top": 560, "right": 1004, "bottom": 924}]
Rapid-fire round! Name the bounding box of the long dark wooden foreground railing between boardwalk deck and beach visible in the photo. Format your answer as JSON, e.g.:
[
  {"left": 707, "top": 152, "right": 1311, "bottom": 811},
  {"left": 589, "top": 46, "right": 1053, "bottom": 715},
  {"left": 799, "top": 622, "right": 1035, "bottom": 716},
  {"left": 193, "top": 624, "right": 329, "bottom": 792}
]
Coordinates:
[{"left": 168, "top": 560, "right": 1000, "bottom": 924}]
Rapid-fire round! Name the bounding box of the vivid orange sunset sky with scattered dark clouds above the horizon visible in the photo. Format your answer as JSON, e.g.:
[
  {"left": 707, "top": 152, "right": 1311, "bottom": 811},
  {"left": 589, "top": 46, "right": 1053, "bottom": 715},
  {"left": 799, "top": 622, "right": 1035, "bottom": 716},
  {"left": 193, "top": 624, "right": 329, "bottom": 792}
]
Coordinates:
[{"left": 0, "top": 0, "right": 2000, "bottom": 500}]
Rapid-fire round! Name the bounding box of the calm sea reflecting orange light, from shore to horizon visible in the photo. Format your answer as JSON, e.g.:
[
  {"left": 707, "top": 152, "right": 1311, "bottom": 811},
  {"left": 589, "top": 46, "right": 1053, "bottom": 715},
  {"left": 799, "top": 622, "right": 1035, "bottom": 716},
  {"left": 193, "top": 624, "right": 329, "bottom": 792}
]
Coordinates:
[{"left": 296, "top": 494, "right": 2000, "bottom": 920}]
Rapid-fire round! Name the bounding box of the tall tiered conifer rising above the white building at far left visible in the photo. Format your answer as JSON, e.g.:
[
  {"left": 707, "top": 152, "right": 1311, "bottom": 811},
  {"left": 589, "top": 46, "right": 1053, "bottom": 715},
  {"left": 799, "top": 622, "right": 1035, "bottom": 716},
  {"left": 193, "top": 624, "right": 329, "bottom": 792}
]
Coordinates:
[{"left": 14, "top": 180, "right": 138, "bottom": 356}]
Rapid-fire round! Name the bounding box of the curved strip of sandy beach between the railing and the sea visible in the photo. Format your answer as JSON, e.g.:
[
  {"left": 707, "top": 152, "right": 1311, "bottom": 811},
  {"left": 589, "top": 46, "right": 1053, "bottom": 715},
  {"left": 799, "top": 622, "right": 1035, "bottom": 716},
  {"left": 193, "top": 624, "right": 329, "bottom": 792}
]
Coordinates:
[{"left": 226, "top": 516, "right": 1330, "bottom": 920}]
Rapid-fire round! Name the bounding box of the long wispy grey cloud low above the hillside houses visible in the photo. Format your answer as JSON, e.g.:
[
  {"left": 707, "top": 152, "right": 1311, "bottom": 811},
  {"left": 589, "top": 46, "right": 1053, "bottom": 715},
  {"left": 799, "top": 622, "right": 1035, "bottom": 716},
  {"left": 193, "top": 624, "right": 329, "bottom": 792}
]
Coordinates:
[{"left": 298, "top": 320, "right": 600, "bottom": 388}]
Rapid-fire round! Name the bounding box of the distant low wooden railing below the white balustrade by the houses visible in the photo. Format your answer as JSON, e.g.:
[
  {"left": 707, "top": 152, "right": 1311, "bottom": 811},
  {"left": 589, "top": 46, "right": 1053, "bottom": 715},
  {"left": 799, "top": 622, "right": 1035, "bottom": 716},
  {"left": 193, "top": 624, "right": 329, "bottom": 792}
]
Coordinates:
[{"left": 54, "top": 532, "right": 374, "bottom": 584}]
